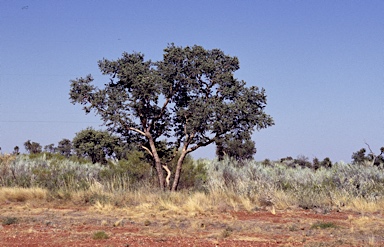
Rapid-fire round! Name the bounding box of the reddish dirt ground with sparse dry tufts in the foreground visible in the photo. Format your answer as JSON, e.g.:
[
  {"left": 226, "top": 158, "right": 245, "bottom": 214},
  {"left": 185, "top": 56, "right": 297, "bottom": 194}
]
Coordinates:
[{"left": 0, "top": 202, "right": 384, "bottom": 247}]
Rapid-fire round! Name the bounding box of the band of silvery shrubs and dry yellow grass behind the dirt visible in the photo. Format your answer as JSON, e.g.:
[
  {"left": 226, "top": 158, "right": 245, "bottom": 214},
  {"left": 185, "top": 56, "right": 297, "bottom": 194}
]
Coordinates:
[{"left": 0, "top": 152, "right": 384, "bottom": 213}]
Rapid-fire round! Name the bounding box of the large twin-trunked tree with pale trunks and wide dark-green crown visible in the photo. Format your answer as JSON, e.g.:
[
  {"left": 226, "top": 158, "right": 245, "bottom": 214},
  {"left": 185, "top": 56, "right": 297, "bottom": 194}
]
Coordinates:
[{"left": 70, "top": 44, "right": 274, "bottom": 191}]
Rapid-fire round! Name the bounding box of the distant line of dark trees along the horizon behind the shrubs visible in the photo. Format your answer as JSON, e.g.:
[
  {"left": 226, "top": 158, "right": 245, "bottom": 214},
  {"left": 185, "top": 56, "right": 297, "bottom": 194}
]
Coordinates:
[{"left": 0, "top": 128, "right": 384, "bottom": 170}]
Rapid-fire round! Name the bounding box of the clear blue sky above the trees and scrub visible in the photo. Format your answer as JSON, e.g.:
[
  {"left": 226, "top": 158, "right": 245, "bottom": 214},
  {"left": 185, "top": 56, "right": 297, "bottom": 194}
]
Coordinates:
[{"left": 0, "top": 0, "right": 384, "bottom": 162}]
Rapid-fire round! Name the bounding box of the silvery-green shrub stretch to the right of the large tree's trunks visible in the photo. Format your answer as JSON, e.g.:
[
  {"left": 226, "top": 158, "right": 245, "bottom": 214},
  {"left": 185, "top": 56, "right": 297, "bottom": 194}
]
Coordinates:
[{"left": 207, "top": 159, "right": 384, "bottom": 208}]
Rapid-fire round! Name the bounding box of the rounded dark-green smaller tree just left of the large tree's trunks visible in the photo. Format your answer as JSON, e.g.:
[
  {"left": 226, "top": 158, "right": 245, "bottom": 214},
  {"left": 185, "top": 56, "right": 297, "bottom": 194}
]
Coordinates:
[{"left": 72, "top": 128, "right": 119, "bottom": 164}]
